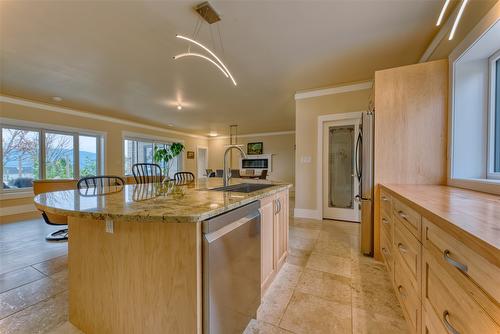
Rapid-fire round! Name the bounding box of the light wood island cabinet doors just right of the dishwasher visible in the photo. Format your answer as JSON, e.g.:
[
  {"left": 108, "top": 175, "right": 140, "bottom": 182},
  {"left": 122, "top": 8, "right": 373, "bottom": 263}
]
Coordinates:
[{"left": 260, "top": 190, "right": 289, "bottom": 295}]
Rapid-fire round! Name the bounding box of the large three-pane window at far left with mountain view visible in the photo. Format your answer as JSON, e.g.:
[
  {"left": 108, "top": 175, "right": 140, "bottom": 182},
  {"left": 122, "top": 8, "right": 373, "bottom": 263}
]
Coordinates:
[{"left": 0, "top": 125, "right": 103, "bottom": 191}]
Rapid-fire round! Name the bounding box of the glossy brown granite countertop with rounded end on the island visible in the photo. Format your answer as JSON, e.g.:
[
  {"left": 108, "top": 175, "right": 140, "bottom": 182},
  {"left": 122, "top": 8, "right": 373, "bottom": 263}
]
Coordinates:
[{"left": 34, "top": 178, "right": 291, "bottom": 223}]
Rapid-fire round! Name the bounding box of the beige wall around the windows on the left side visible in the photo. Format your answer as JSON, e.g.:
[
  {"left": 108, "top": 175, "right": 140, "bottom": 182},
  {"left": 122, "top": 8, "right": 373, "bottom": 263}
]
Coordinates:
[{"left": 0, "top": 98, "right": 208, "bottom": 221}]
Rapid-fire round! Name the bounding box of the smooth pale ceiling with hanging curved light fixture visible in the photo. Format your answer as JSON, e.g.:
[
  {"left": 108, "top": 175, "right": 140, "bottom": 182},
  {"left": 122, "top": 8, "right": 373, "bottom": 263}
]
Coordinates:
[{"left": 0, "top": 0, "right": 454, "bottom": 134}]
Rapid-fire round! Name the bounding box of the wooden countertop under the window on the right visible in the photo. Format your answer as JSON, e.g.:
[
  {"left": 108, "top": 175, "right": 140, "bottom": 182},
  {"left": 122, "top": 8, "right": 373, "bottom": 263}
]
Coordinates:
[{"left": 381, "top": 184, "right": 500, "bottom": 265}]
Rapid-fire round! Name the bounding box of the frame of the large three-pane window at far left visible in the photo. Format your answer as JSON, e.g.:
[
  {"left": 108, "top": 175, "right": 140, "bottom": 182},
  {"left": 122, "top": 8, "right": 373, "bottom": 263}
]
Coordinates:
[{"left": 0, "top": 118, "right": 106, "bottom": 195}]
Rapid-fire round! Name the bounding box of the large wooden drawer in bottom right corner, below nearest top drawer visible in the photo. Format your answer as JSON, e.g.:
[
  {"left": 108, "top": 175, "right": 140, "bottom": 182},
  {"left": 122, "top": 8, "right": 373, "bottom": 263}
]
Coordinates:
[{"left": 423, "top": 249, "right": 500, "bottom": 334}]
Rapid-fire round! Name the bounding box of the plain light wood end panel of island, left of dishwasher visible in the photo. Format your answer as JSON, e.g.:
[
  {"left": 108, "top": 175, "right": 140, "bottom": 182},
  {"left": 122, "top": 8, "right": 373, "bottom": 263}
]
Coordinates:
[{"left": 68, "top": 217, "right": 201, "bottom": 334}]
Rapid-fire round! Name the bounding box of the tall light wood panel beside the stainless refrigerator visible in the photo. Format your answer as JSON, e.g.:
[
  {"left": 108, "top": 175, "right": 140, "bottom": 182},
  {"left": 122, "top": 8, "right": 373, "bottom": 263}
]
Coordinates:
[{"left": 374, "top": 60, "right": 448, "bottom": 258}]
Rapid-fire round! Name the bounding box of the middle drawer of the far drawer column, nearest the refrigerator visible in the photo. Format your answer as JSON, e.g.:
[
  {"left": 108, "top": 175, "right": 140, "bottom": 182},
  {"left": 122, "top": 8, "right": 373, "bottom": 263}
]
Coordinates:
[{"left": 393, "top": 221, "right": 422, "bottom": 291}]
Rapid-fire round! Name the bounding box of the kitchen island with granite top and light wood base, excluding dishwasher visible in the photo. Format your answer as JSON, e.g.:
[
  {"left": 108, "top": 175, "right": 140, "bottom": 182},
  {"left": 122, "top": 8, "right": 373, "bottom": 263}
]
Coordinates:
[{"left": 35, "top": 178, "right": 290, "bottom": 334}]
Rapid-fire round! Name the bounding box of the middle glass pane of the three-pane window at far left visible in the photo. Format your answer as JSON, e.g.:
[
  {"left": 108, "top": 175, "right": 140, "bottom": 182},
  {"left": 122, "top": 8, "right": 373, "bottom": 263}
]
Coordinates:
[{"left": 45, "top": 132, "right": 75, "bottom": 179}]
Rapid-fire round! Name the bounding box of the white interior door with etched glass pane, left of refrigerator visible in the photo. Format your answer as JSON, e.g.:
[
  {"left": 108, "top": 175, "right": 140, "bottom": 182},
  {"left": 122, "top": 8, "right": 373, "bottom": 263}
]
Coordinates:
[{"left": 323, "top": 119, "right": 360, "bottom": 222}]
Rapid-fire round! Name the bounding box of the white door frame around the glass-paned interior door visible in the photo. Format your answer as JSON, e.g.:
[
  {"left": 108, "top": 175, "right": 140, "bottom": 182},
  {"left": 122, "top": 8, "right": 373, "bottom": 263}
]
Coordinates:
[{"left": 316, "top": 111, "right": 363, "bottom": 219}]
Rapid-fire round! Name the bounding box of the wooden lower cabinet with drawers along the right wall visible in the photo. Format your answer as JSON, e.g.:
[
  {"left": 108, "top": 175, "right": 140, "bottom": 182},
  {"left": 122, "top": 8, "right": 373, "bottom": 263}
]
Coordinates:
[{"left": 379, "top": 191, "right": 500, "bottom": 334}]
